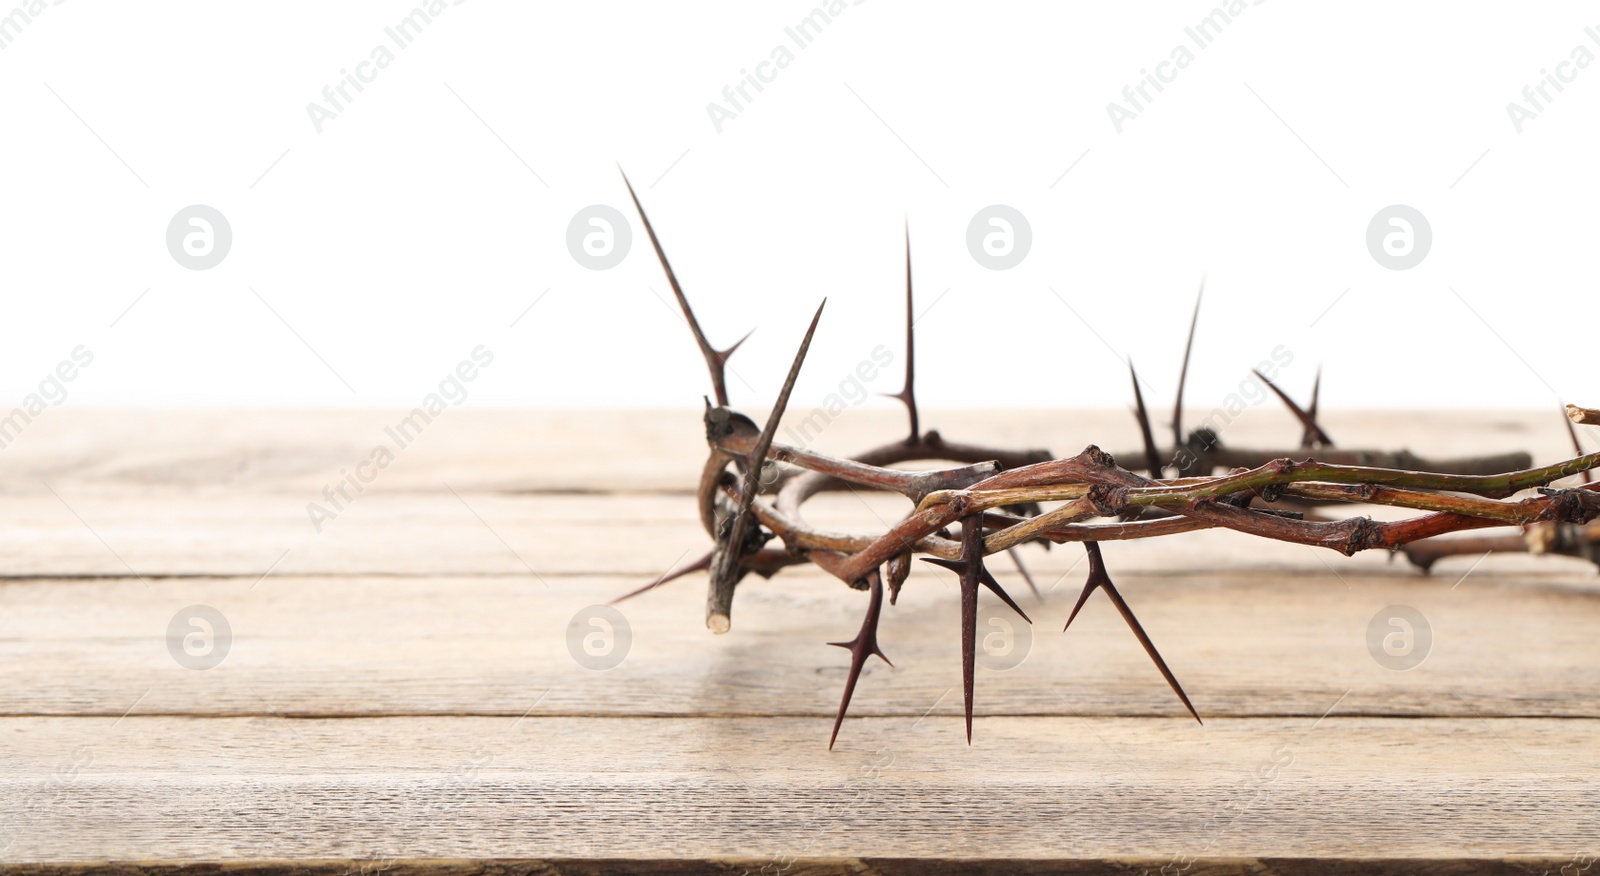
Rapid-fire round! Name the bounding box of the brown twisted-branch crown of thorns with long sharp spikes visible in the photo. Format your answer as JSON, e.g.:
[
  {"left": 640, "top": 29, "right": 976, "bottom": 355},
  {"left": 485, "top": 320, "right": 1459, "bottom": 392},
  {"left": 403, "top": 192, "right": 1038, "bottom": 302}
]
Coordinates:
[{"left": 616, "top": 176, "right": 1600, "bottom": 748}]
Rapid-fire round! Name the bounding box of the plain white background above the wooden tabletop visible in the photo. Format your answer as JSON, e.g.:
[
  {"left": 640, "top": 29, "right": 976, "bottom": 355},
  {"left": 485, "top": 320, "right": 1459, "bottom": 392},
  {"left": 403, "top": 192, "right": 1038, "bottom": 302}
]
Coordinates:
[{"left": 0, "top": 0, "right": 1600, "bottom": 419}]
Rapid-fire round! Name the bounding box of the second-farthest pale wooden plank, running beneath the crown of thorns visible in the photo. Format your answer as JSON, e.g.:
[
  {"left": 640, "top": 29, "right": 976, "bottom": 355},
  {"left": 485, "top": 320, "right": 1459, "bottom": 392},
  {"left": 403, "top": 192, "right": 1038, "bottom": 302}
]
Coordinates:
[{"left": 12, "top": 484, "right": 1595, "bottom": 588}]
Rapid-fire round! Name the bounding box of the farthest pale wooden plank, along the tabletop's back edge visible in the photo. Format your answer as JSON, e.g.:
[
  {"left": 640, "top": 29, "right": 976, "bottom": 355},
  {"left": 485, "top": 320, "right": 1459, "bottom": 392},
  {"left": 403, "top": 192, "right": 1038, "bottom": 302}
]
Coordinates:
[{"left": 0, "top": 407, "right": 1571, "bottom": 494}]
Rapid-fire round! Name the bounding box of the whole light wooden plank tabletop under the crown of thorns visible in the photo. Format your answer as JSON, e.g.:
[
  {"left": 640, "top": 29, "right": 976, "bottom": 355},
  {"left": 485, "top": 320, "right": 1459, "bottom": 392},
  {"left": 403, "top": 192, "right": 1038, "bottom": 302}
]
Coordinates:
[{"left": 0, "top": 408, "right": 1600, "bottom": 873}]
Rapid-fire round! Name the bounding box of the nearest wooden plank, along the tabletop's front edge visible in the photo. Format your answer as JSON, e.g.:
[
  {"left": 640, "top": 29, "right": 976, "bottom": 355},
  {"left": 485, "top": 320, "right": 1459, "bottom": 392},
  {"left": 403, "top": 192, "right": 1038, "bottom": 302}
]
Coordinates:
[{"left": 0, "top": 713, "right": 1600, "bottom": 873}]
